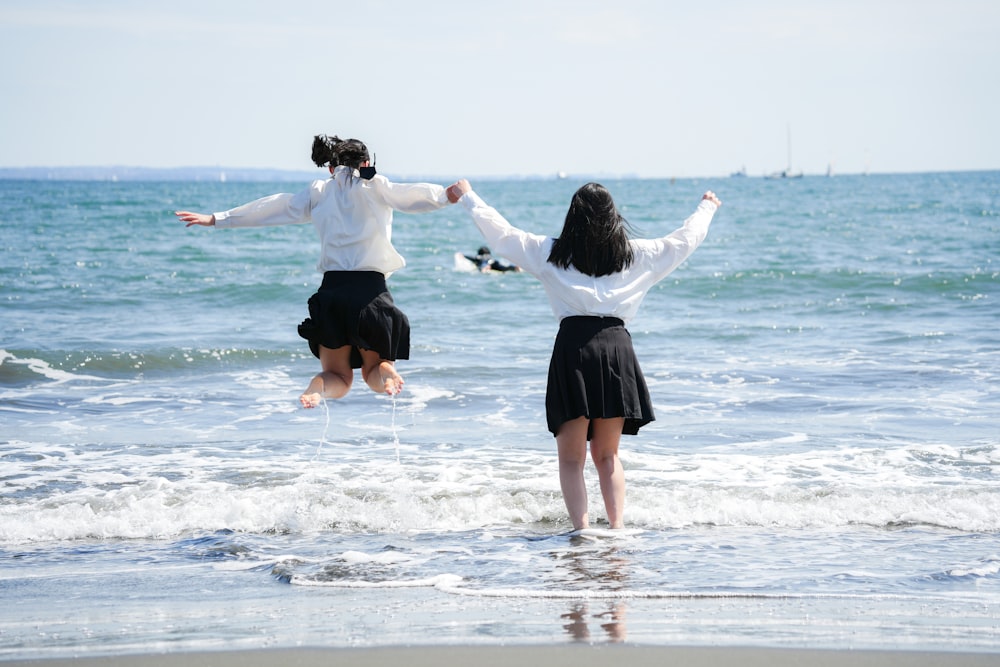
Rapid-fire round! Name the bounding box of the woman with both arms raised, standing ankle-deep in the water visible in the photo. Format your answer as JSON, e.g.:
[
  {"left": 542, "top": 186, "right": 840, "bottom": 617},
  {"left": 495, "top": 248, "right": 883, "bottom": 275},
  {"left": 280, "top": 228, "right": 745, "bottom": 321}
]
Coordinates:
[{"left": 448, "top": 180, "right": 721, "bottom": 530}]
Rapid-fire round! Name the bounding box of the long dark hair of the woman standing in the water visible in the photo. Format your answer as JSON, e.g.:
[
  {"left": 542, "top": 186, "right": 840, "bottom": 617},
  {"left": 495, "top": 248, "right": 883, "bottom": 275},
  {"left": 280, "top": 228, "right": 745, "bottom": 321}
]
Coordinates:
[{"left": 549, "top": 183, "right": 635, "bottom": 276}]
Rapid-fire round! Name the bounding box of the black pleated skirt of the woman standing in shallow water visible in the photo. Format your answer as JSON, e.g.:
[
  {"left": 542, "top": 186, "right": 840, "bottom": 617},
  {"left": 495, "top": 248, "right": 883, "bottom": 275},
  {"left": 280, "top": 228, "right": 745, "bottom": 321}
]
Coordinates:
[{"left": 545, "top": 317, "right": 655, "bottom": 440}]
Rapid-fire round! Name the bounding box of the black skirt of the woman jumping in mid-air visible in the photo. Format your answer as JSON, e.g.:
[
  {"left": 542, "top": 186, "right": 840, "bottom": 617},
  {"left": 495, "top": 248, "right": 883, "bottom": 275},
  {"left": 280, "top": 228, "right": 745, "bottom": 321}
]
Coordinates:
[{"left": 299, "top": 271, "right": 410, "bottom": 368}]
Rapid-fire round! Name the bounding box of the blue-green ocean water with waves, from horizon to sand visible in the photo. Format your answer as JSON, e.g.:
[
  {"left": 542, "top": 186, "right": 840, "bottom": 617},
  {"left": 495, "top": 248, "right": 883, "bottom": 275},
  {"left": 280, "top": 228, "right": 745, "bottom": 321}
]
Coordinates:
[{"left": 0, "top": 172, "right": 1000, "bottom": 659}]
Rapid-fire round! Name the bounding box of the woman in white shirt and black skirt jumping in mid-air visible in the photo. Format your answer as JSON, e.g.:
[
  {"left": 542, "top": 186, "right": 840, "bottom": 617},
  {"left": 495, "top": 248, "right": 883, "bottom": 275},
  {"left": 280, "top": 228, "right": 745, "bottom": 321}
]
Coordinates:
[{"left": 176, "top": 134, "right": 448, "bottom": 408}]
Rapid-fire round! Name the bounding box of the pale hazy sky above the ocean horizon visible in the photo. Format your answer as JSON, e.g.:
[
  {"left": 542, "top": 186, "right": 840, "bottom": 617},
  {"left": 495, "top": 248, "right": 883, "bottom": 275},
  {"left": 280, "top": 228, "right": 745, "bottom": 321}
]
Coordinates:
[{"left": 0, "top": 0, "right": 1000, "bottom": 177}]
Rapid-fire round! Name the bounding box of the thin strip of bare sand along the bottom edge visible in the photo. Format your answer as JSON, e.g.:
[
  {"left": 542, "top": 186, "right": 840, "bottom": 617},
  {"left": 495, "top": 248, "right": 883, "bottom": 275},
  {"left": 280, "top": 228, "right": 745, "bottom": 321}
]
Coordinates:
[{"left": 5, "top": 646, "right": 1000, "bottom": 667}]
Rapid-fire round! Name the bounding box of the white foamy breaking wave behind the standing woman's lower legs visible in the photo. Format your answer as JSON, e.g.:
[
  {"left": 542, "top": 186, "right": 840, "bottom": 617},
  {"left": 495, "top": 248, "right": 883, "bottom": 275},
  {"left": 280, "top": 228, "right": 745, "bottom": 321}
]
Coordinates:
[{"left": 0, "top": 441, "right": 1000, "bottom": 544}]
